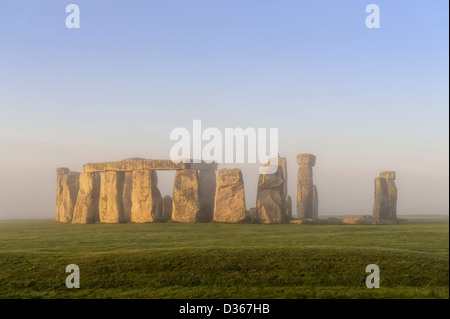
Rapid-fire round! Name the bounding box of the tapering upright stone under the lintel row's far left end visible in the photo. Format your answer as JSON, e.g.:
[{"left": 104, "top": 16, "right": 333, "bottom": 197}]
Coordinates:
[{"left": 72, "top": 173, "right": 100, "bottom": 224}]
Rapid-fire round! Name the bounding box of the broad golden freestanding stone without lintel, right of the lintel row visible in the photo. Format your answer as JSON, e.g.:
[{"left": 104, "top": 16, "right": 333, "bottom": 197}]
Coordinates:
[{"left": 214, "top": 168, "right": 245, "bottom": 223}]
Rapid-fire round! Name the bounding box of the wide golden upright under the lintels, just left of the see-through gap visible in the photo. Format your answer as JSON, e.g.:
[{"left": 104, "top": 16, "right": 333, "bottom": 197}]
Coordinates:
[{"left": 131, "top": 170, "right": 163, "bottom": 223}]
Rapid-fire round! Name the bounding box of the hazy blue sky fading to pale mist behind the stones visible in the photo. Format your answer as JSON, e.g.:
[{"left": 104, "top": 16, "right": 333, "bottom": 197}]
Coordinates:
[{"left": 0, "top": 0, "right": 449, "bottom": 218}]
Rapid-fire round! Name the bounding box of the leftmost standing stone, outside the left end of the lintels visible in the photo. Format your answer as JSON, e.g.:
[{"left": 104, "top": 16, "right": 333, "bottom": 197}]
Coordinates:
[{"left": 58, "top": 172, "right": 80, "bottom": 223}]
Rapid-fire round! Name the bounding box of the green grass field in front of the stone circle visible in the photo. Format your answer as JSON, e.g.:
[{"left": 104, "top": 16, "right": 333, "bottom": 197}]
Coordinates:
[{"left": 0, "top": 216, "right": 449, "bottom": 298}]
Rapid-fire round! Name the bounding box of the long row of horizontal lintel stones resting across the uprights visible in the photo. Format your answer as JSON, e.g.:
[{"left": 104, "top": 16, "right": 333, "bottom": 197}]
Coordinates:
[{"left": 83, "top": 158, "right": 217, "bottom": 173}]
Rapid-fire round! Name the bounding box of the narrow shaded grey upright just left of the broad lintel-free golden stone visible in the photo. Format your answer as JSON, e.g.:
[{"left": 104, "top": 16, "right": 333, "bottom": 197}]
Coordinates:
[{"left": 198, "top": 170, "right": 216, "bottom": 222}]
